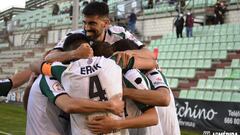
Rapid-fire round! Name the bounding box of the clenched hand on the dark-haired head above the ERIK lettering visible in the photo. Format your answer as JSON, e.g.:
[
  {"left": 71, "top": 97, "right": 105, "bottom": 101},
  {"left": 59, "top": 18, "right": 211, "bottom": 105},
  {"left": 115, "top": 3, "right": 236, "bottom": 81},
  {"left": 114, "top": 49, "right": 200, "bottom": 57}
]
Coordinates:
[{"left": 73, "top": 43, "right": 93, "bottom": 59}]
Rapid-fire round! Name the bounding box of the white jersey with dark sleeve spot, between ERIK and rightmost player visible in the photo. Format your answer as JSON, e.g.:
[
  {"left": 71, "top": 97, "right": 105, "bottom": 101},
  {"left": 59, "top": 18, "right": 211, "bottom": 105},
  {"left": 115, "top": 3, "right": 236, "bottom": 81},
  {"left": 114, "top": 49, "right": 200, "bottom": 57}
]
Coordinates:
[{"left": 124, "top": 69, "right": 163, "bottom": 135}]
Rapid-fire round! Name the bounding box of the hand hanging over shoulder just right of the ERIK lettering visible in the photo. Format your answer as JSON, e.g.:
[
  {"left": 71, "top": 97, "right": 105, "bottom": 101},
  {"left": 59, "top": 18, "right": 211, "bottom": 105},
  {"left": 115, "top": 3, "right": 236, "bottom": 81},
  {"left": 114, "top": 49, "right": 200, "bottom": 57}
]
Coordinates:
[{"left": 113, "top": 51, "right": 133, "bottom": 68}]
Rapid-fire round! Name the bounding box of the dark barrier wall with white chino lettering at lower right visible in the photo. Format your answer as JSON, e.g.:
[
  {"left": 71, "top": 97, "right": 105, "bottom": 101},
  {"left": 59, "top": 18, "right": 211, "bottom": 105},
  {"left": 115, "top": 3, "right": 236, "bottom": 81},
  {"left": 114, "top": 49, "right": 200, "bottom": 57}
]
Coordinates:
[{"left": 176, "top": 99, "right": 240, "bottom": 132}]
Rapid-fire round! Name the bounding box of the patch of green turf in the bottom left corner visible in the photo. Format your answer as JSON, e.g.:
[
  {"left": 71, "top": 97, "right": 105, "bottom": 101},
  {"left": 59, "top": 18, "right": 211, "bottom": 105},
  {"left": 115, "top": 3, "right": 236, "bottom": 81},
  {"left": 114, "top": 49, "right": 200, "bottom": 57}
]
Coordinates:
[{"left": 0, "top": 103, "right": 26, "bottom": 135}]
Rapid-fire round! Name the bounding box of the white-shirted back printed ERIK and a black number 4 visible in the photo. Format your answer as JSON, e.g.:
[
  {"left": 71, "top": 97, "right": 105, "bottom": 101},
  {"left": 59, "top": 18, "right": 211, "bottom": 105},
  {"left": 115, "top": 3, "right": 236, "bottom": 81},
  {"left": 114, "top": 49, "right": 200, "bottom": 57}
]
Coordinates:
[{"left": 61, "top": 57, "right": 128, "bottom": 135}]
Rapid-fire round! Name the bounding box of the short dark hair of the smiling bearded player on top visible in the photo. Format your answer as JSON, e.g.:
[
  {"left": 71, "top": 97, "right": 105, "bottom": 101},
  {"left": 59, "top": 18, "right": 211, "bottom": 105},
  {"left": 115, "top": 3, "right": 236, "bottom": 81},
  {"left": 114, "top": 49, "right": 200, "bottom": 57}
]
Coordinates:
[{"left": 82, "top": 1, "right": 109, "bottom": 17}]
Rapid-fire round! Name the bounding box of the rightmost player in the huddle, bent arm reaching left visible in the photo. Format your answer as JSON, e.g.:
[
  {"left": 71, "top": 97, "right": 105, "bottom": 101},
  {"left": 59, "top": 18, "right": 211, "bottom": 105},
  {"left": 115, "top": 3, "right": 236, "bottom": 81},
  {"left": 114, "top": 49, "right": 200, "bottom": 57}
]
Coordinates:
[{"left": 92, "top": 40, "right": 180, "bottom": 135}]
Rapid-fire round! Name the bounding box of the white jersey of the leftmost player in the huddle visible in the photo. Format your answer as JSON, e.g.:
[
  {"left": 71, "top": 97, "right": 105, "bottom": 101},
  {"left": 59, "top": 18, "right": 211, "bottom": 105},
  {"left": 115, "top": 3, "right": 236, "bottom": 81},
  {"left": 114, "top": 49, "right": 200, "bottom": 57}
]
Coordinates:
[{"left": 26, "top": 75, "right": 71, "bottom": 135}]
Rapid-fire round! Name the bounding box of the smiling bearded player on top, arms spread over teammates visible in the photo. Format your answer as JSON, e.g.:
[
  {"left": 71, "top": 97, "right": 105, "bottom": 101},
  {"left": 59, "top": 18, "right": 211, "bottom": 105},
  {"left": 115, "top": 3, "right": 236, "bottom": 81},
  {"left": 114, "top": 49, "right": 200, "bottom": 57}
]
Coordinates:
[{"left": 46, "top": 2, "right": 156, "bottom": 69}]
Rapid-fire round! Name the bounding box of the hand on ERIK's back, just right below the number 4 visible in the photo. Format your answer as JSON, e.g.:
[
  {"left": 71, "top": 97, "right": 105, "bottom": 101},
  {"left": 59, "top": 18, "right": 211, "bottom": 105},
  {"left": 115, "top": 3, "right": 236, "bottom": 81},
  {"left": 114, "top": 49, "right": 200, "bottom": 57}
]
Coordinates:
[{"left": 107, "top": 94, "right": 124, "bottom": 117}]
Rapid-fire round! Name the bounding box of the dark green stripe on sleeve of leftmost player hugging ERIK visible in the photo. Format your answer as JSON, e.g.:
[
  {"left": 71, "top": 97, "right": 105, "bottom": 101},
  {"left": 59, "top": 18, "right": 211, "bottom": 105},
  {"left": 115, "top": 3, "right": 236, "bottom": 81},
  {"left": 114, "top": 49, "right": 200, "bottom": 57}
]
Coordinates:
[{"left": 39, "top": 75, "right": 56, "bottom": 103}]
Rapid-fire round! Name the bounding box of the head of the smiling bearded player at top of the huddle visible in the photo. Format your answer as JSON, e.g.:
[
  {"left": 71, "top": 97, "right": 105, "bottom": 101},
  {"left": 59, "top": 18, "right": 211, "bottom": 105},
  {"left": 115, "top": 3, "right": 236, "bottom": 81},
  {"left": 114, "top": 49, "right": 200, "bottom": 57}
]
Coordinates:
[{"left": 82, "top": 2, "right": 110, "bottom": 41}]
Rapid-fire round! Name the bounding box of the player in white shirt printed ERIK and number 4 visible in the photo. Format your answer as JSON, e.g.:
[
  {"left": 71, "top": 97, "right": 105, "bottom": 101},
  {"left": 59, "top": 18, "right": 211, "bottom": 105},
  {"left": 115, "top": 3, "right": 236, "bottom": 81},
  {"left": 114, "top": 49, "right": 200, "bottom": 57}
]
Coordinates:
[{"left": 30, "top": 36, "right": 127, "bottom": 135}]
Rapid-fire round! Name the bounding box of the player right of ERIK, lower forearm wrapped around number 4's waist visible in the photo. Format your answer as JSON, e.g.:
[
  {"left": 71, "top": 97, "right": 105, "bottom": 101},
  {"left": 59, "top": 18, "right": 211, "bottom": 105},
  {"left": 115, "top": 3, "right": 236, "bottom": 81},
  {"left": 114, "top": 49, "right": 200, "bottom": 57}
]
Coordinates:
[{"left": 88, "top": 69, "right": 162, "bottom": 135}]
